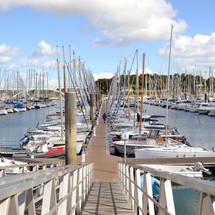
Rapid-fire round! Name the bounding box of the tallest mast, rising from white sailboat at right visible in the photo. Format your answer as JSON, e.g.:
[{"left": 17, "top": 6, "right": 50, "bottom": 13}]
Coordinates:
[{"left": 165, "top": 25, "right": 173, "bottom": 144}]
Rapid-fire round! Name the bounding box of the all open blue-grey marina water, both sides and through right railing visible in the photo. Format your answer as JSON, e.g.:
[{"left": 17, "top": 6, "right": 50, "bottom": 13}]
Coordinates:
[{"left": 0, "top": 105, "right": 215, "bottom": 215}]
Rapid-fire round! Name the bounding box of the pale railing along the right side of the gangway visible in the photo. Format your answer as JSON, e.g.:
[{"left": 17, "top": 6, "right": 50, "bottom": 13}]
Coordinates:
[{"left": 118, "top": 161, "right": 215, "bottom": 215}]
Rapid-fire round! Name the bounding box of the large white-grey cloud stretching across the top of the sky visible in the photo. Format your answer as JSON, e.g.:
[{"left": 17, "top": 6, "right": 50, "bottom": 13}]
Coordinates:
[{"left": 0, "top": 0, "right": 187, "bottom": 46}]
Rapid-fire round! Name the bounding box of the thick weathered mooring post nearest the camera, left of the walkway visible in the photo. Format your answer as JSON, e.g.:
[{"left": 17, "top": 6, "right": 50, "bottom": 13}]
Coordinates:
[{"left": 65, "top": 92, "right": 77, "bottom": 165}]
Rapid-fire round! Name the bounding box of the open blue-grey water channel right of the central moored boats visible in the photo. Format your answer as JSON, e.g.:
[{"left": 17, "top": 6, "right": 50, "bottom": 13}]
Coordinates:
[{"left": 144, "top": 105, "right": 215, "bottom": 149}]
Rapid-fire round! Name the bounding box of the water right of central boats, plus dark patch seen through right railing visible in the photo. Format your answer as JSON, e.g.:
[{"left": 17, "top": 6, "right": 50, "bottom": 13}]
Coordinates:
[{"left": 141, "top": 105, "right": 215, "bottom": 215}]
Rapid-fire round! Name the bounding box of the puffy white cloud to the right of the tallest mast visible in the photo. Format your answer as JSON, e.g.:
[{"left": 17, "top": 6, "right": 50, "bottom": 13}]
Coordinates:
[{"left": 160, "top": 33, "right": 215, "bottom": 71}]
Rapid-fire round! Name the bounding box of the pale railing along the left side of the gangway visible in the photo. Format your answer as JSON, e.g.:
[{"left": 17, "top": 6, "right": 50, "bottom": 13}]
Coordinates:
[{"left": 0, "top": 163, "right": 94, "bottom": 215}]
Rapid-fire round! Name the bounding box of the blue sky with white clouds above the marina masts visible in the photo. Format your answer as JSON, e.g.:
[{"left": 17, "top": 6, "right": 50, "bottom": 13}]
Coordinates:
[{"left": 0, "top": 0, "right": 215, "bottom": 87}]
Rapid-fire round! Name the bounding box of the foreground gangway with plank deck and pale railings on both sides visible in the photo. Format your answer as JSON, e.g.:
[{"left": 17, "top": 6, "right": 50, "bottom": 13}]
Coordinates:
[{"left": 0, "top": 160, "right": 215, "bottom": 215}]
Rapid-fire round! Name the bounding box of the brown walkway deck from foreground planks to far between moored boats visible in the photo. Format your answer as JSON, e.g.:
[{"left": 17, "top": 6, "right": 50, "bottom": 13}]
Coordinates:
[{"left": 81, "top": 102, "right": 134, "bottom": 215}]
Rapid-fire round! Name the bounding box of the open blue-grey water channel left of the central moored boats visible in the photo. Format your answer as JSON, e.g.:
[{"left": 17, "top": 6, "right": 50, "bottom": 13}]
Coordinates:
[{"left": 0, "top": 107, "right": 57, "bottom": 147}]
